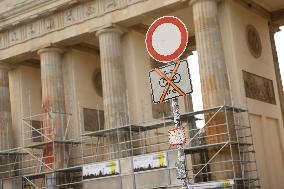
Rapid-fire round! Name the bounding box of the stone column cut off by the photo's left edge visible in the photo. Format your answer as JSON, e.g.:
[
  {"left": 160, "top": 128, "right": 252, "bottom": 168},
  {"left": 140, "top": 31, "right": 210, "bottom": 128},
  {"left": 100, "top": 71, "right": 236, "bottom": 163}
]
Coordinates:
[{"left": 0, "top": 65, "right": 13, "bottom": 151}]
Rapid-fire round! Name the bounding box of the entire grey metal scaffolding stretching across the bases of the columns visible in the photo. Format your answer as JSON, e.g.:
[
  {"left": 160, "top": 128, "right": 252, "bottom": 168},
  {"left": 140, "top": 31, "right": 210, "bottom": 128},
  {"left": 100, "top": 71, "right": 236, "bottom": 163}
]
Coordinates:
[{"left": 0, "top": 106, "right": 260, "bottom": 188}]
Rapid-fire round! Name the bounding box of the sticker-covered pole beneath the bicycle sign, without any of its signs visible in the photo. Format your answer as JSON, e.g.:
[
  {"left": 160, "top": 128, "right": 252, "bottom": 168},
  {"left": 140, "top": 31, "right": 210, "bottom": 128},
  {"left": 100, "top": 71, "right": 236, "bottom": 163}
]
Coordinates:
[{"left": 172, "top": 98, "right": 188, "bottom": 189}]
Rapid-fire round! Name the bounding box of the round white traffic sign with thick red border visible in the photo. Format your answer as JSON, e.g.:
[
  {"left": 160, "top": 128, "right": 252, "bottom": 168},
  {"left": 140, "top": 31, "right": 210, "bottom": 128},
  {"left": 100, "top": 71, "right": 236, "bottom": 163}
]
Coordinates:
[{"left": 145, "top": 16, "right": 188, "bottom": 63}]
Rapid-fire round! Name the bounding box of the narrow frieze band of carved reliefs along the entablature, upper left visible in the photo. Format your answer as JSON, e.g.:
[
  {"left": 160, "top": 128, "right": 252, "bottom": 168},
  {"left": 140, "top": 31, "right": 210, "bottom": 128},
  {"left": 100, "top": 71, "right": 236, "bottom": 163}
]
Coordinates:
[{"left": 0, "top": 0, "right": 145, "bottom": 49}]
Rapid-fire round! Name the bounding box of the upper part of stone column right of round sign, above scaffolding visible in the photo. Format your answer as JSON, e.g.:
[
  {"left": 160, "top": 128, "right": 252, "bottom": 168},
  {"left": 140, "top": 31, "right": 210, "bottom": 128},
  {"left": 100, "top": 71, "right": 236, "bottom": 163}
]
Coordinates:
[{"left": 191, "top": 0, "right": 231, "bottom": 108}]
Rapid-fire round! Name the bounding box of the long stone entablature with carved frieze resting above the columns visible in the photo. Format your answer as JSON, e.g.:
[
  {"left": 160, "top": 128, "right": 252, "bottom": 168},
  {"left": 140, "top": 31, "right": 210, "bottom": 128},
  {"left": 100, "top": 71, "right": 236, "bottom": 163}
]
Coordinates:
[{"left": 0, "top": 0, "right": 188, "bottom": 60}]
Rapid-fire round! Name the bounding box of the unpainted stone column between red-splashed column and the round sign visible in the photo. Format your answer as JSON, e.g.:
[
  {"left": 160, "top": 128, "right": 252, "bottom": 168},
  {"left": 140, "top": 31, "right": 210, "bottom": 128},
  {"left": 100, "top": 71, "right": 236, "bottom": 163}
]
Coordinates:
[{"left": 96, "top": 27, "right": 128, "bottom": 158}]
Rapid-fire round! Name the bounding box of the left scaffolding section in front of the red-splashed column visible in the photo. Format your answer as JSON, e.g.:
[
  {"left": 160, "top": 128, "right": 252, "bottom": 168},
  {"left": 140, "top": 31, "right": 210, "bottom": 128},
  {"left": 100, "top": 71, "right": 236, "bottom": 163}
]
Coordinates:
[{"left": 0, "top": 112, "right": 81, "bottom": 188}]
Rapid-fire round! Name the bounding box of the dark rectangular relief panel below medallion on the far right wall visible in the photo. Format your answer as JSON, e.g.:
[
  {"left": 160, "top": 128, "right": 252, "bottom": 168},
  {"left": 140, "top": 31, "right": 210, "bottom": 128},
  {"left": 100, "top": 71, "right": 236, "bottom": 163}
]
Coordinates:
[{"left": 243, "top": 71, "right": 276, "bottom": 104}]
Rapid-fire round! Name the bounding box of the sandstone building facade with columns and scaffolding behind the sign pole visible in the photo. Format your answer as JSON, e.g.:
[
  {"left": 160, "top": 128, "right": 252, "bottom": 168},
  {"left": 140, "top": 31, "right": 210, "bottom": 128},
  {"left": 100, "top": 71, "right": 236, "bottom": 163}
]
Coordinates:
[{"left": 0, "top": 0, "right": 284, "bottom": 189}]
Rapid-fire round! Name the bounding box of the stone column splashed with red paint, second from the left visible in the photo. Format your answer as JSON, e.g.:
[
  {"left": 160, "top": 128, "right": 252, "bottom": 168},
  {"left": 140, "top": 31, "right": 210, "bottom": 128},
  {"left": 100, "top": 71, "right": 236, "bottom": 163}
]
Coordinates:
[{"left": 38, "top": 48, "right": 68, "bottom": 188}]
